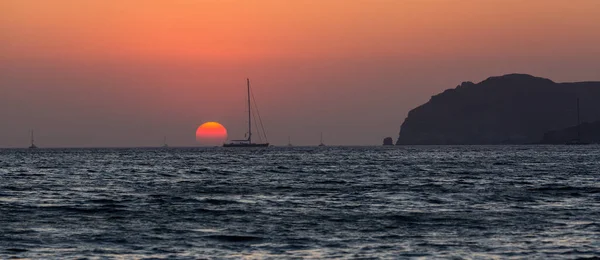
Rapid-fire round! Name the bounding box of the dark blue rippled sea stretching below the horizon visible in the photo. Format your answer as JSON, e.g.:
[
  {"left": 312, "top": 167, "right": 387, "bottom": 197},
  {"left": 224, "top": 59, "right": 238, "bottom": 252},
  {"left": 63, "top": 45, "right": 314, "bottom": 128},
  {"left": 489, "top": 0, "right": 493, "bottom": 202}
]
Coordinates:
[{"left": 0, "top": 146, "right": 600, "bottom": 259}]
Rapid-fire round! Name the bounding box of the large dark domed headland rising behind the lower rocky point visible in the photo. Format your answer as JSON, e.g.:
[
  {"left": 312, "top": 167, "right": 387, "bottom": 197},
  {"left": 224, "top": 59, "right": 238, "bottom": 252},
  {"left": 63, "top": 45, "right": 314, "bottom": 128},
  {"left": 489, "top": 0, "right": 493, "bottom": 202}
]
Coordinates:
[{"left": 396, "top": 74, "right": 600, "bottom": 145}]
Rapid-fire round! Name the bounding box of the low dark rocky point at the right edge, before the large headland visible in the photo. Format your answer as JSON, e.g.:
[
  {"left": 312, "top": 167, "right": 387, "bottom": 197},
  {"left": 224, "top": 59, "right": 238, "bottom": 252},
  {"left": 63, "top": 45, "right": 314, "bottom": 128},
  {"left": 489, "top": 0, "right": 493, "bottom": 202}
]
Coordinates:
[{"left": 540, "top": 121, "right": 600, "bottom": 144}]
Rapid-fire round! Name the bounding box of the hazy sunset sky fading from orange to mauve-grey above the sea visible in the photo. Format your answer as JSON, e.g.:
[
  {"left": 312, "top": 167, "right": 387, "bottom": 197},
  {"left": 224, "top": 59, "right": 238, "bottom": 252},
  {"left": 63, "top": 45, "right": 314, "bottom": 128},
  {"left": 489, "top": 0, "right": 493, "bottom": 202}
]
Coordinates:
[{"left": 0, "top": 0, "right": 600, "bottom": 147}]
